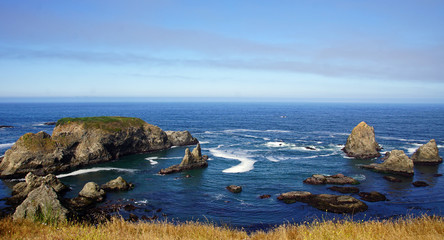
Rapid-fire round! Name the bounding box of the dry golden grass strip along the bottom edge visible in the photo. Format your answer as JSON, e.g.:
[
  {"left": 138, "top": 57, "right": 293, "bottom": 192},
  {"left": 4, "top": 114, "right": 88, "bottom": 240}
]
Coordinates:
[{"left": 0, "top": 216, "right": 444, "bottom": 240}]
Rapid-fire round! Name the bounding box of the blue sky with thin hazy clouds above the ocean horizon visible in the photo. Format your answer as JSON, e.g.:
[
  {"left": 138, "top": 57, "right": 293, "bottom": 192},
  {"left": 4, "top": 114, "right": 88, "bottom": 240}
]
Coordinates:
[{"left": 0, "top": 0, "right": 444, "bottom": 103}]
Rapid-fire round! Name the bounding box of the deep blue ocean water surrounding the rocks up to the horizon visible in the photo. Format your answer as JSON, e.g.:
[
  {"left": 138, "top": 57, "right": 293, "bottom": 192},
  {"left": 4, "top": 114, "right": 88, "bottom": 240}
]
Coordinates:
[{"left": 0, "top": 103, "right": 444, "bottom": 229}]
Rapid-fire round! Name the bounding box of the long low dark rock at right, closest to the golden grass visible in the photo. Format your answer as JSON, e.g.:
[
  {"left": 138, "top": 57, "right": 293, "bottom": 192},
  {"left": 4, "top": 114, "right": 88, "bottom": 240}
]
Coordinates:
[{"left": 278, "top": 191, "right": 368, "bottom": 213}]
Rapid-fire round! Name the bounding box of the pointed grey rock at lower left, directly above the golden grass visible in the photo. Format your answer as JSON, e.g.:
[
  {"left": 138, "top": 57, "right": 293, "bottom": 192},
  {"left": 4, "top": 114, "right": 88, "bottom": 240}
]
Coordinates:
[{"left": 12, "top": 184, "right": 68, "bottom": 222}]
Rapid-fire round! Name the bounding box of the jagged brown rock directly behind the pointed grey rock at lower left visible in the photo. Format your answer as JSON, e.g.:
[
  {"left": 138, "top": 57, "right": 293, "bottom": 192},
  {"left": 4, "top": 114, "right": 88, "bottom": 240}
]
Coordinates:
[{"left": 6, "top": 172, "right": 69, "bottom": 205}]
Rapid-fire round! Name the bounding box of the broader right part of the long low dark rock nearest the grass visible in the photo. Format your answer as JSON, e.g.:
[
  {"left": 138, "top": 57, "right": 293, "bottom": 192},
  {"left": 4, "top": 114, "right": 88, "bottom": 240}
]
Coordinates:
[{"left": 309, "top": 194, "right": 368, "bottom": 213}]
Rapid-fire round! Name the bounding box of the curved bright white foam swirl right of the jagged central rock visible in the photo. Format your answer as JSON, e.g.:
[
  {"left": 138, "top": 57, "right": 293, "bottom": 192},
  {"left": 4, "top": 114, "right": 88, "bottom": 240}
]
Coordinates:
[{"left": 210, "top": 149, "right": 256, "bottom": 173}]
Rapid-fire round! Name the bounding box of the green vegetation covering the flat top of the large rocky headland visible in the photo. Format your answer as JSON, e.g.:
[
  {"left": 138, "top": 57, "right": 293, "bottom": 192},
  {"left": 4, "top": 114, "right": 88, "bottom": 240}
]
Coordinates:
[{"left": 56, "top": 116, "right": 146, "bottom": 132}]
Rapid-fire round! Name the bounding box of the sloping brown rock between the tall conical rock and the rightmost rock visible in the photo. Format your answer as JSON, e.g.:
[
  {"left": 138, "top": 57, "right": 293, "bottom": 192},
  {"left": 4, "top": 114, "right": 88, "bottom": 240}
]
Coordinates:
[{"left": 362, "top": 150, "right": 414, "bottom": 176}]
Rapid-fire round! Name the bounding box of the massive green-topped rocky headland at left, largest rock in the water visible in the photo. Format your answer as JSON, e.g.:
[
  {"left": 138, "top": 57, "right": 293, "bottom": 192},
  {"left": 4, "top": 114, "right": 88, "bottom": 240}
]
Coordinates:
[{"left": 0, "top": 117, "right": 195, "bottom": 178}]
